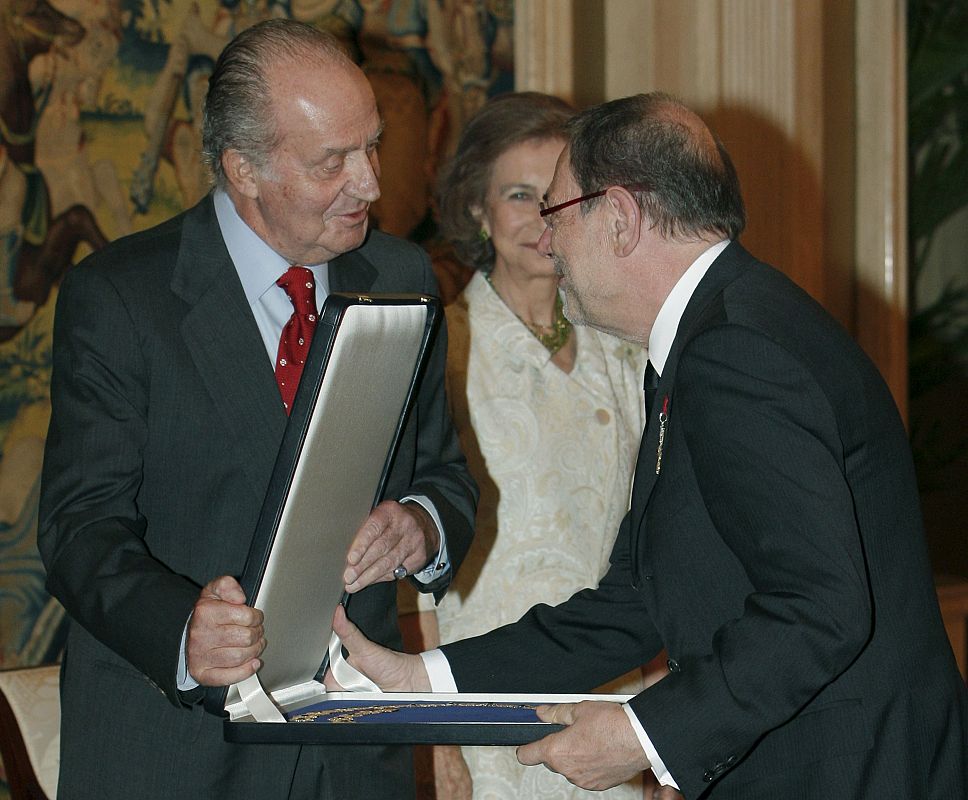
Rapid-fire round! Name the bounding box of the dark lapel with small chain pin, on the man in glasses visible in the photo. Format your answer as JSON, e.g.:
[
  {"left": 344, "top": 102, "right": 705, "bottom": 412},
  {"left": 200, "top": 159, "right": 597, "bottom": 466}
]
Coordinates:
[{"left": 630, "top": 241, "right": 754, "bottom": 586}]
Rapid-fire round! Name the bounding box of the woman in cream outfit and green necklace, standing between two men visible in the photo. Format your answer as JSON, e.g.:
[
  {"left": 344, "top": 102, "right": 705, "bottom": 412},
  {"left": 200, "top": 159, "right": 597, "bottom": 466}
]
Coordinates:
[{"left": 400, "top": 92, "right": 646, "bottom": 800}]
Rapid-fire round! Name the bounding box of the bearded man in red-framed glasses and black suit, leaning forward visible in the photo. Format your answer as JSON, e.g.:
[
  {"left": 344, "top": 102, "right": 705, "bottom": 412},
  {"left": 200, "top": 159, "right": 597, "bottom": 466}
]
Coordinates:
[{"left": 336, "top": 94, "right": 968, "bottom": 800}]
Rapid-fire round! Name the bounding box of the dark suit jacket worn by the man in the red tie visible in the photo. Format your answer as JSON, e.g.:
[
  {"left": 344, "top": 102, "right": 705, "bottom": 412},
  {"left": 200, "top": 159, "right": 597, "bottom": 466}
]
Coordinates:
[{"left": 38, "top": 198, "right": 476, "bottom": 797}]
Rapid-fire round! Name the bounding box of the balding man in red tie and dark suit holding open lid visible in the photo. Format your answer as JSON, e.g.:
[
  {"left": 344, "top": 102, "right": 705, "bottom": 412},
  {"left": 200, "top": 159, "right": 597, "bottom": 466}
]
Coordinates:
[{"left": 39, "top": 20, "right": 476, "bottom": 800}]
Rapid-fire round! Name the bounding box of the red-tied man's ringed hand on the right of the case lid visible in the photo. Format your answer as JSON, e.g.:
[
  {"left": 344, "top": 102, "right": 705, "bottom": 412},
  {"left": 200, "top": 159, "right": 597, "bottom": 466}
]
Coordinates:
[{"left": 343, "top": 500, "right": 440, "bottom": 594}]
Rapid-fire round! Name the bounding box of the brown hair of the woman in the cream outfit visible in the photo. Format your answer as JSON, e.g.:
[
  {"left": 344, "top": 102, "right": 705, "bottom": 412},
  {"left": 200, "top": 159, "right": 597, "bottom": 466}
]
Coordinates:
[{"left": 437, "top": 92, "right": 575, "bottom": 269}]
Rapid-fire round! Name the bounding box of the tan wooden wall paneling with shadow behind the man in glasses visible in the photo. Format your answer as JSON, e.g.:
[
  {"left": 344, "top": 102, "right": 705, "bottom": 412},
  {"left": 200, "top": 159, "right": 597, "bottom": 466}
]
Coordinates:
[{"left": 516, "top": 0, "right": 907, "bottom": 411}]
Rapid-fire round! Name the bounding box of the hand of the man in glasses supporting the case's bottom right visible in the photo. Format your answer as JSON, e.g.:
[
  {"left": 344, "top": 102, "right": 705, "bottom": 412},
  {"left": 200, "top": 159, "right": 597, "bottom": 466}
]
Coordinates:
[{"left": 518, "top": 700, "right": 651, "bottom": 791}]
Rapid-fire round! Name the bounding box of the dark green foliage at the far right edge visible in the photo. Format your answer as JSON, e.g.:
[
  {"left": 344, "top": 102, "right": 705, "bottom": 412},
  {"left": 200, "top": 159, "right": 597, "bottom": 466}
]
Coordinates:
[{"left": 908, "top": 0, "right": 968, "bottom": 478}]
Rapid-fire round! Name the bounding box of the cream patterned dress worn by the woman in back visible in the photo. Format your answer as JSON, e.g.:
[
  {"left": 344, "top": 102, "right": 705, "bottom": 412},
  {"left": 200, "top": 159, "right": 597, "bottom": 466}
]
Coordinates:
[{"left": 422, "top": 272, "right": 646, "bottom": 800}]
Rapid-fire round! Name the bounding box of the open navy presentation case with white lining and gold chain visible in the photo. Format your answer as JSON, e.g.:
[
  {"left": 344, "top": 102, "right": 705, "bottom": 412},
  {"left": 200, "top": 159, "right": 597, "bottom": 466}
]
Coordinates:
[{"left": 205, "top": 293, "right": 626, "bottom": 745}]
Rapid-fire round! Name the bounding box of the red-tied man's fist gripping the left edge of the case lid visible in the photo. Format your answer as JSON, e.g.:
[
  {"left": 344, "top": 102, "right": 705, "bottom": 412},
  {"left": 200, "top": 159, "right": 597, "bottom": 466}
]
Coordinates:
[{"left": 185, "top": 575, "right": 266, "bottom": 686}]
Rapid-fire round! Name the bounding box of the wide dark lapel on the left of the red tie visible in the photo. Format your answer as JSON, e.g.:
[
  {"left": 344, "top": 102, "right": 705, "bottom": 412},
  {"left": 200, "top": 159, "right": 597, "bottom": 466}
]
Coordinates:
[{"left": 172, "top": 197, "right": 287, "bottom": 491}]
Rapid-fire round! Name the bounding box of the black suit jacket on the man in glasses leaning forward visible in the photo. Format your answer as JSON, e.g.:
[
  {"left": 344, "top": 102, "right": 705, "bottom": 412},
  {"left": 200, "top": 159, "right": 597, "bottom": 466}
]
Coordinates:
[{"left": 444, "top": 243, "right": 968, "bottom": 800}]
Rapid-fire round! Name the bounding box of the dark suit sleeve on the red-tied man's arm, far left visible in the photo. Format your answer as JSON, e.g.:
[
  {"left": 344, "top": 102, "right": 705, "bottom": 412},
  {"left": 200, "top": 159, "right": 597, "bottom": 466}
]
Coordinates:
[{"left": 38, "top": 266, "right": 199, "bottom": 702}]
